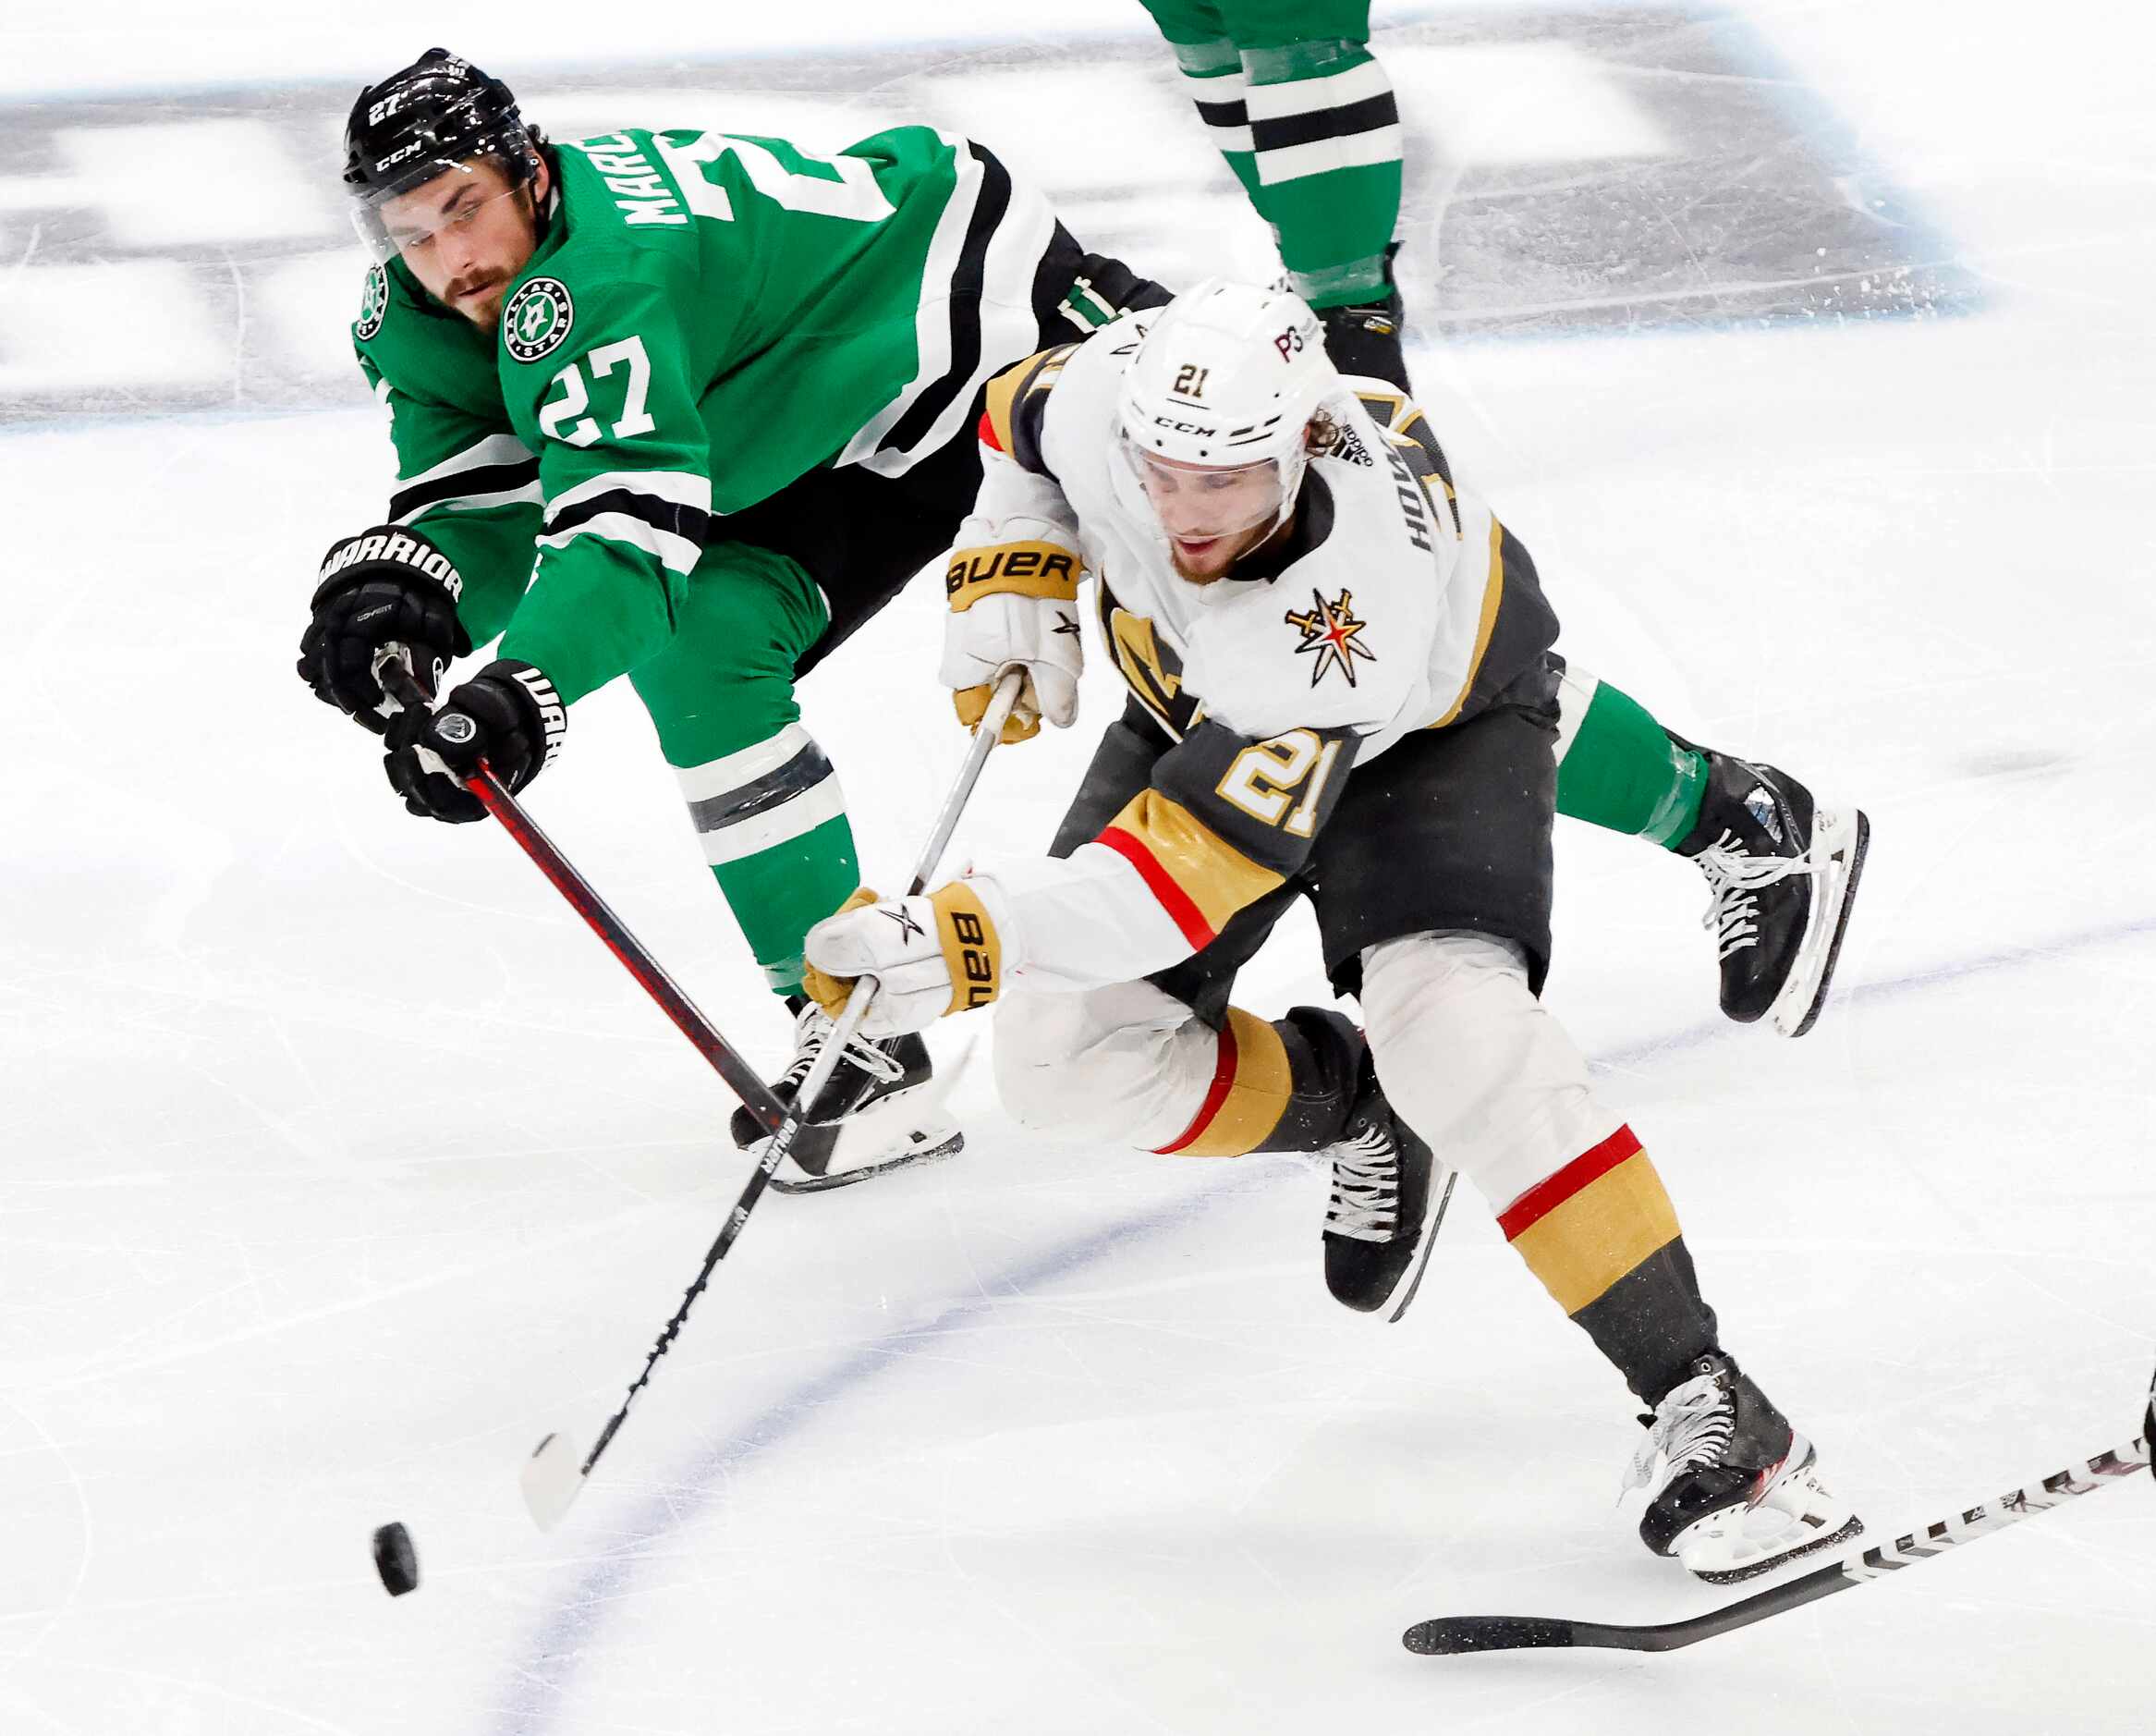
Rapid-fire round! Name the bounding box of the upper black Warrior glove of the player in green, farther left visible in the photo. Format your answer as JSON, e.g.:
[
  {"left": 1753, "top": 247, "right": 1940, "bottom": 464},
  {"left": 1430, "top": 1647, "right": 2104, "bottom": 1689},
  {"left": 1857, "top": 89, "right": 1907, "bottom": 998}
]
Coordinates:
[{"left": 299, "top": 524, "right": 472, "bottom": 736}]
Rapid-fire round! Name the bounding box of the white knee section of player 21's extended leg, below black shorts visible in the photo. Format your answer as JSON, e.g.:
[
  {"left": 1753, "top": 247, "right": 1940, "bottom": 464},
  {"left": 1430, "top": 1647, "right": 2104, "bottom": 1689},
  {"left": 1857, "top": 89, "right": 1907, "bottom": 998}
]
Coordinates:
[{"left": 1362, "top": 932, "right": 1617, "bottom": 1207}]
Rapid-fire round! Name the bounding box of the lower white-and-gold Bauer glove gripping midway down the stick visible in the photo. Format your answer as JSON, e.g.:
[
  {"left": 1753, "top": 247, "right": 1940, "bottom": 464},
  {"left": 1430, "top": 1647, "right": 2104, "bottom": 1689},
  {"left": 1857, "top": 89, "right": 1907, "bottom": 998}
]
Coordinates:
[{"left": 802, "top": 880, "right": 1003, "bottom": 1037}]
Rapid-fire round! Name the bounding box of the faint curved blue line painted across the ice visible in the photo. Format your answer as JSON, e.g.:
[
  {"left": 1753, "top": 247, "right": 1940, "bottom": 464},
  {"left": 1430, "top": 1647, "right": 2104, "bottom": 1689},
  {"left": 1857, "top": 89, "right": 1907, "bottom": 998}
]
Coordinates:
[{"left": 492, "top": 919, "right": 2156, "bottom": 1736}]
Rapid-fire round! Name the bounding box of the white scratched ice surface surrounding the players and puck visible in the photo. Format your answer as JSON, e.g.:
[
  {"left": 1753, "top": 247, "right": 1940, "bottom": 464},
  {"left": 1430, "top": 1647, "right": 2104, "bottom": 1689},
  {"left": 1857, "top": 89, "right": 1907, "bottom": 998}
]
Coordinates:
[{"left": 0, "top": 0, "right": 2156, "bottom": 1736}]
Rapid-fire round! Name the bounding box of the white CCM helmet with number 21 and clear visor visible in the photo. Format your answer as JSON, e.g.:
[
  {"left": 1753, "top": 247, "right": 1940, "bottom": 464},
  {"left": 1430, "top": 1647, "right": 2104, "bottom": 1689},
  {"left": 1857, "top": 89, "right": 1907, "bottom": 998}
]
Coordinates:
[{"left": 1116, "top": 278, "right": 1339, "bottom": 568}]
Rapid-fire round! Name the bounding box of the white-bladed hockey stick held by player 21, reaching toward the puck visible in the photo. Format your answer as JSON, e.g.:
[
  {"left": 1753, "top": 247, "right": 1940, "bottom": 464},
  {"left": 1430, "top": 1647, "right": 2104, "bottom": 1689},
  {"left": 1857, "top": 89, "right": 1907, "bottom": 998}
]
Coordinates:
[{"left": 513, "top": 671, "right": 1024, "bottom": 1531}]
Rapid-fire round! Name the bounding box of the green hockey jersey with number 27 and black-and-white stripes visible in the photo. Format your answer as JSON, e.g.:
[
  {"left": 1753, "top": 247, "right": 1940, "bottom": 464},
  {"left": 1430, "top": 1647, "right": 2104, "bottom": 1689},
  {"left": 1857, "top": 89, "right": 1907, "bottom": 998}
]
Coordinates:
[{"left": 354, "top": 128, "right": 1054, "bottom": 701}]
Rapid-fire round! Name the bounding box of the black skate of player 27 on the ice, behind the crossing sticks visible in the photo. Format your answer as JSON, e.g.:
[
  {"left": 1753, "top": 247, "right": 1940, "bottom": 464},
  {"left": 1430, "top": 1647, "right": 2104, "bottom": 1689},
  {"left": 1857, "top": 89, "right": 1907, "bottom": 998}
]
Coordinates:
[{"left": 731, "top": 994, "right": 966, "bottom": 1192}]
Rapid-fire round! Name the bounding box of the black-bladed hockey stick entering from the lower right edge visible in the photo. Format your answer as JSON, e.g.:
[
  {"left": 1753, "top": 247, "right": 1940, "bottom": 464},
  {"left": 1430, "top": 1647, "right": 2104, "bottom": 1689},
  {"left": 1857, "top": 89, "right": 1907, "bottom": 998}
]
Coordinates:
[{"left": 1401, "top": 1411, "right": 2156, "bottom": 1657}]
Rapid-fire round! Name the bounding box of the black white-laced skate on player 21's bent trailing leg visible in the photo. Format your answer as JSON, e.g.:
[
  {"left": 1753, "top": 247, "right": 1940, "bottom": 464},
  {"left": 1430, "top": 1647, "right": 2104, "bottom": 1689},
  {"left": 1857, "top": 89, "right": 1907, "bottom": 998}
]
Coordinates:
[{"left": 1326, "top": 1057, "right": 1453, "bottom": 1320}]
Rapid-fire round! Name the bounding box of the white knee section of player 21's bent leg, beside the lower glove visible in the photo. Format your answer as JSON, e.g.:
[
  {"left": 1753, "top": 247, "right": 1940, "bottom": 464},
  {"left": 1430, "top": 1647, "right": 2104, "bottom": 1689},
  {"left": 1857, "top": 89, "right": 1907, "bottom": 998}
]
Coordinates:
[{"left": 996, "top": 984, "right": 1218, "bottom": 1152}]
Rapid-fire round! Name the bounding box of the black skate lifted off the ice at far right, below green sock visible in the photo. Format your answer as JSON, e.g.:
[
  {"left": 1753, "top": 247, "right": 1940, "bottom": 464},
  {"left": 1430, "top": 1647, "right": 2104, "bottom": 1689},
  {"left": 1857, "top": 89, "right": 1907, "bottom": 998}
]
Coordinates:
[{"left": 1671, "top": 738, "right": 1871, "bottom": 1037}]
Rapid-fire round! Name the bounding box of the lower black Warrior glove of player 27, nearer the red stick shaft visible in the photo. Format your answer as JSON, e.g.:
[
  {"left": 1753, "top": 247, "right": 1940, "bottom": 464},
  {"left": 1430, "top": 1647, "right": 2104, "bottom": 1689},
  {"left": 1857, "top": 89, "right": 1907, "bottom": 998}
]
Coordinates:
[{"left": 382, "top": 658, "right": 569, "bottom": 826}]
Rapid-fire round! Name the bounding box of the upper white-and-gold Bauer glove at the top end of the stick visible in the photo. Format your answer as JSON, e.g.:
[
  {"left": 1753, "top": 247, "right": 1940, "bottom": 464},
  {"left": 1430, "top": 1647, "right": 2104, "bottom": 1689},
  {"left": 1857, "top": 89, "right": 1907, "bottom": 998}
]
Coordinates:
[{"left": 940, "top": 542, "right": 1084, "bottom": 742}]
